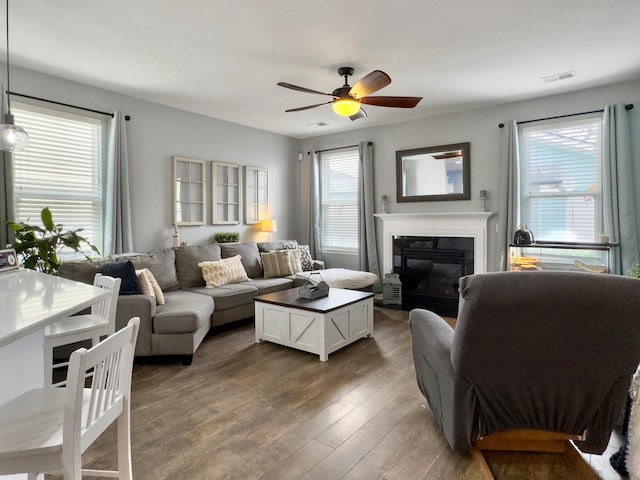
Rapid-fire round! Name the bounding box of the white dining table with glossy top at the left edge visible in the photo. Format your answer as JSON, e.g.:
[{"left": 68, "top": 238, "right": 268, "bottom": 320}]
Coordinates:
[{"left": 0, "top": 269, "right": 108, "bottom": 480}]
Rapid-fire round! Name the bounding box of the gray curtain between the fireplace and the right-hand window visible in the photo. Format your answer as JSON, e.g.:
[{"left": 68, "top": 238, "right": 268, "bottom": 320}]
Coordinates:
[{"left": 496, "top": 120, "right": 520, "bottom": 270}]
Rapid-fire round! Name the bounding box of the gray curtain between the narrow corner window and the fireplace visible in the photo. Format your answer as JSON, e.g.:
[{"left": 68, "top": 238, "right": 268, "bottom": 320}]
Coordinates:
[{"left": 358, "top": 142, "right": 382, "bottom": 292}]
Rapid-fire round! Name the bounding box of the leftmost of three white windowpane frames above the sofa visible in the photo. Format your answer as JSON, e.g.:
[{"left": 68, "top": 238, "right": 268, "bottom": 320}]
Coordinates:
[{"left": 173, "top": 157, "right": 205, "bottom": 225}]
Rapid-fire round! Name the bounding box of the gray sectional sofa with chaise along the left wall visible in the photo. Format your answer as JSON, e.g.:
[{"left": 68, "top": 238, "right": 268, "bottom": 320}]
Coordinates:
[{"left": 59, "top": 240, "right": 324, "bottom": 364}]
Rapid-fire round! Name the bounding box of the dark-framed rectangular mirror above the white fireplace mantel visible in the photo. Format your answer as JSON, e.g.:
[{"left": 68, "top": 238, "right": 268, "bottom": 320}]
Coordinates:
[{"left": 396, "top": 142, "right": 471, "bottom": 202}]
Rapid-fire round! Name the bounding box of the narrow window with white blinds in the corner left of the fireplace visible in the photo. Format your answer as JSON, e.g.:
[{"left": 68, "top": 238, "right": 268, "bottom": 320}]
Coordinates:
[{"left": 320, "top": 148, "right": 359, "bottom": 253}]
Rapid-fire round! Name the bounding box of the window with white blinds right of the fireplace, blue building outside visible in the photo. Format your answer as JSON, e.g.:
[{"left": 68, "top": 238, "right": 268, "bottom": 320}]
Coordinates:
[{"left": 520, "top": 114, "right": 603, "bottom": 242}]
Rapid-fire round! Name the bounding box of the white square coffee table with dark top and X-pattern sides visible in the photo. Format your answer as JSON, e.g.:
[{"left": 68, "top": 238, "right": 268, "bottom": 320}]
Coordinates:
[{"left": 254, "top": 288, "right": 373, "bottom": 362}]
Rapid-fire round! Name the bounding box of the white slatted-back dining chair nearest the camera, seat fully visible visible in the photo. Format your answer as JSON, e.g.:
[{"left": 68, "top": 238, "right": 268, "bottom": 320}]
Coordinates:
[{"left": 0, "top": 317, "right": 140, "bottom": 480}]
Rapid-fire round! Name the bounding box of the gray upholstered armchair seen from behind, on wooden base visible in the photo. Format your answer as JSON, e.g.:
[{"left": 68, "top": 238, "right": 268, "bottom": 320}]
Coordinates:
[{"left": 409, "top": 271, "right": 640, "bottom": 474}]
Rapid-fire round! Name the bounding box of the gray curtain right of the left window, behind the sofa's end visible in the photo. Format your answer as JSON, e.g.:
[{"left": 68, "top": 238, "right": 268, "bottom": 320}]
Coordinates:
[{"left": 102, "top": 112, "right": 134, "bottom": 255}]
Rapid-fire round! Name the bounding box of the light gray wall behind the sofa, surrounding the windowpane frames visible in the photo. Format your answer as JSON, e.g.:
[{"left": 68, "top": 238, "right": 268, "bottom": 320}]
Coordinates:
[{"left": 8, "top": 66, "right": 300, "bottom": 252}]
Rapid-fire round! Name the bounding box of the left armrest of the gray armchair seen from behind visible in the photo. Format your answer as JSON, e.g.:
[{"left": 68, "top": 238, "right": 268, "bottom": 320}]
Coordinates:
[{"left": 409, "top": 309, "right": 477, "bottom": 451}]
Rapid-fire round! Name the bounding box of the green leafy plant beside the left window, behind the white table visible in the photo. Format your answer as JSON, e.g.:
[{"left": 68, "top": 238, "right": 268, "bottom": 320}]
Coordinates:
[{"left": 7, "top": 207, "right": 100, "bottom": 275}]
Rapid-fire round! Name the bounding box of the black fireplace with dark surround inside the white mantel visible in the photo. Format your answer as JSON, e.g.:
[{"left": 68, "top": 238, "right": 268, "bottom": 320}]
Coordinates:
[{"left": 393, "top": 236, "right": 474, "bottom": 317}]
